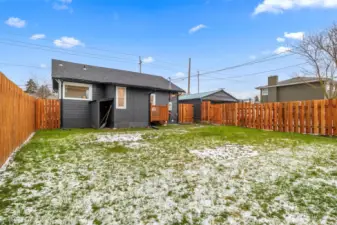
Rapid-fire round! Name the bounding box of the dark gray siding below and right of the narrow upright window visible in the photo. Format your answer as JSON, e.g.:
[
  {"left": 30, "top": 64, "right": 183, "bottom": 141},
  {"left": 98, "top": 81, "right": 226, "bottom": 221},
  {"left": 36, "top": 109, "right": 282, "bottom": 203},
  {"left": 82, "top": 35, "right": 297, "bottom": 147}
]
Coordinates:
[{"left": 114, "top": 87, "right": 150, "bottom": 128}]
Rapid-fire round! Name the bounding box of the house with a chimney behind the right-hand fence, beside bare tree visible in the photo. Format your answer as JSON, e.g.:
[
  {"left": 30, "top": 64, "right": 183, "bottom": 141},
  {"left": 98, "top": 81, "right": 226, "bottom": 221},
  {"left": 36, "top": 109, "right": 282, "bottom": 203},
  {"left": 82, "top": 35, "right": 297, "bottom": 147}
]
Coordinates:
[{"left": 256, "top": 76, "right": 329, "bottom": 103}]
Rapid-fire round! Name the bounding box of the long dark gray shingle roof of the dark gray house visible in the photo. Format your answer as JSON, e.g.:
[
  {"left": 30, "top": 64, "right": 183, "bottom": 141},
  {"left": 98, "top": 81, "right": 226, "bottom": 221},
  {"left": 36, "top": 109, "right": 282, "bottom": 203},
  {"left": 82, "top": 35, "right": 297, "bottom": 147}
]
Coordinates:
[{"left": 52, "top": 59, "right": 184, "bottom": 92}]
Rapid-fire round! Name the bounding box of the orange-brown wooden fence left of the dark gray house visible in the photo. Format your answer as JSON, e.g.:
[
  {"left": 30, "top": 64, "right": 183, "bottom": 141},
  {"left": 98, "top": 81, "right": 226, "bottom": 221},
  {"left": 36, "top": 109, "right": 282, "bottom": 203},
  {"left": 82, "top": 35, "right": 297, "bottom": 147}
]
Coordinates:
[{"left": 0, "top": 72, "right": 60, "bottom": 166}]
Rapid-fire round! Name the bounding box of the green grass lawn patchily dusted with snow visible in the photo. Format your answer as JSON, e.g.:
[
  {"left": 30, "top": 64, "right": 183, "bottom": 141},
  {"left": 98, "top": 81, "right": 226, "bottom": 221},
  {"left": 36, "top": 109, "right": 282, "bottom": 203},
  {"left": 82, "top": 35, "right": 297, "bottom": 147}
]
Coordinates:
[{"left": 0, "top": 126, "right": 337, "bottom": 225}]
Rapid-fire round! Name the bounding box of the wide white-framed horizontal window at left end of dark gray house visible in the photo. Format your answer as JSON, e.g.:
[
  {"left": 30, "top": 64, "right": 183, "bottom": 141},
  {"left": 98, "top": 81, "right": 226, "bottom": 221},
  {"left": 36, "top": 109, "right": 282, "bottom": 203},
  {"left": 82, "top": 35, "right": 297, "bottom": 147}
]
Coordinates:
[{"left": 63, "top": 82, "right": 92, "bottom": 100}]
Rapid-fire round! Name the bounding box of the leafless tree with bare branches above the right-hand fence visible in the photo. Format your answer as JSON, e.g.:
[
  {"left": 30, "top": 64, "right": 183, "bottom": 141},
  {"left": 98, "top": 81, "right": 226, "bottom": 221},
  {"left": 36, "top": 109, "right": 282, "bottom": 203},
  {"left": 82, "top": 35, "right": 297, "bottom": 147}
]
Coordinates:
[{"left": 291, "top": 24, "right": 337, "bottom": 99}]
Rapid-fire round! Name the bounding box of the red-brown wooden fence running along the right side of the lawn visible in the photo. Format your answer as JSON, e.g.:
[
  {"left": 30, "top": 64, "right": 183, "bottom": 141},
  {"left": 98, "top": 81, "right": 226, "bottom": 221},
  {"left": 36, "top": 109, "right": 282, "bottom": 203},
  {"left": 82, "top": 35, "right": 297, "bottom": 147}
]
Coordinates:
[{"left": 201, "top": 99, "right": 337, "bottom": 136}]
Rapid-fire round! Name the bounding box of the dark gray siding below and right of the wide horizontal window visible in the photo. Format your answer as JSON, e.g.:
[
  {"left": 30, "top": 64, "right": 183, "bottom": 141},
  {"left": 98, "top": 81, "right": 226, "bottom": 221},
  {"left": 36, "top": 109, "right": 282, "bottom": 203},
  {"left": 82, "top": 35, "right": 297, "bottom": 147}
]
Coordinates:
[{"left": 62, "top": 84, "right": 104, "bottom": 128}]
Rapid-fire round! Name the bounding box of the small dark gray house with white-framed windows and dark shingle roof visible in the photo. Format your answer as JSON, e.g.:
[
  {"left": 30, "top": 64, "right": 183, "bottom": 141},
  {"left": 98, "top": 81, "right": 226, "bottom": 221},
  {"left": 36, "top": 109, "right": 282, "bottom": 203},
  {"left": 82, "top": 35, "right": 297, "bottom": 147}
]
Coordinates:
[{"left": 52, "top": 60, "right": 184, "bottom": 128}]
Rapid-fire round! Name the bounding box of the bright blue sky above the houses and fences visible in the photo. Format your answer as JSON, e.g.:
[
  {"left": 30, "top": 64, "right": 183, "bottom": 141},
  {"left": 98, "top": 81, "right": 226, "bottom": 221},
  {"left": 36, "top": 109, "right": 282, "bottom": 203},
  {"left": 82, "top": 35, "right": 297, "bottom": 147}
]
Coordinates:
[{"left": 0, "top": 0, "right": 337, "bottom": 98}]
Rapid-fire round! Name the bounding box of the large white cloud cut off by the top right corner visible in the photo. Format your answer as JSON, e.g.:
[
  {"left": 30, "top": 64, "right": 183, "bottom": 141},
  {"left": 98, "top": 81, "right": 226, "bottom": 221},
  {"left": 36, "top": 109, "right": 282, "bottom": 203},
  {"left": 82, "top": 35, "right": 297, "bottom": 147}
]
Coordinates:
[{"left": 253, "top": 0, "right": 337, "bottom": 15}]
